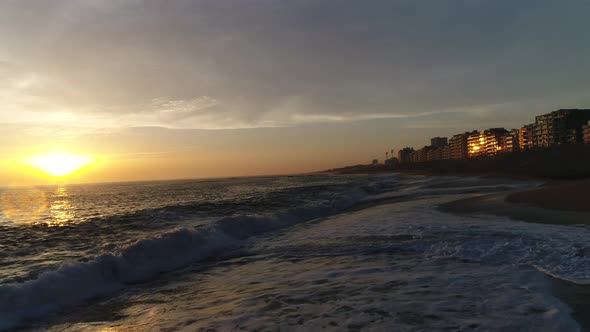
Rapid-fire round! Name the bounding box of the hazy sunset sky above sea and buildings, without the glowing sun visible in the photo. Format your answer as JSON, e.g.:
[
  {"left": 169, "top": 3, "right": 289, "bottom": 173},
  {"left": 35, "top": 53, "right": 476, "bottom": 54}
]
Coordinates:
[{"left": 0, "top": 0, "right": 590, "bottom": 185}]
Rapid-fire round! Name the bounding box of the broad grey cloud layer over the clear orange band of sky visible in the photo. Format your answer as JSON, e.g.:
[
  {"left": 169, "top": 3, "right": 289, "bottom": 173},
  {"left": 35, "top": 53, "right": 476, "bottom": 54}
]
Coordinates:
[{"left": 0, "top": 0, "right": 590, "bottom": 129}]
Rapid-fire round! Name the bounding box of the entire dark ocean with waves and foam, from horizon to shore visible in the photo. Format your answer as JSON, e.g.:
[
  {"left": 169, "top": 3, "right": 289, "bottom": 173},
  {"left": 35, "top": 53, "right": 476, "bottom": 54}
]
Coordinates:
[{"left": 0, "top": 174, "right": 590, "bottom": 331}]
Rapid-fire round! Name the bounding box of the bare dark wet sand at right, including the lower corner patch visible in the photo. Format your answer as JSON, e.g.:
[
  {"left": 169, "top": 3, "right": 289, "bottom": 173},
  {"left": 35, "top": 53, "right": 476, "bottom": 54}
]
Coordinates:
[{"left": 439, "top": 180, "right": 590, "bottom": 331}]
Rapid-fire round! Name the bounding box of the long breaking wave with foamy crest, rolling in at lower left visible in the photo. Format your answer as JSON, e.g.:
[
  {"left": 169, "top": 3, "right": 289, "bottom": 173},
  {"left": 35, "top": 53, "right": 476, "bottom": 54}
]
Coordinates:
[{"left": 0, "top": 189, "right": 368, "bottom": 330}]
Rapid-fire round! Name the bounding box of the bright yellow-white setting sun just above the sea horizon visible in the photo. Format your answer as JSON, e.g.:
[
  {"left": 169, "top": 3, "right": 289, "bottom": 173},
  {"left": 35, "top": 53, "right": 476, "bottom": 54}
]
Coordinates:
[{"left": 23, "top": 152, "right": 94, "bottom": 177}]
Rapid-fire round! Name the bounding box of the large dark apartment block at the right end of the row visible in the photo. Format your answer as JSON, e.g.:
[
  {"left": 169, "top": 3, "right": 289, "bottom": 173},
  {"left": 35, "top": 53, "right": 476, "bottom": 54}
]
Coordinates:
[{"left": 534, "top": 109, "right": 590, "bottom": 148}]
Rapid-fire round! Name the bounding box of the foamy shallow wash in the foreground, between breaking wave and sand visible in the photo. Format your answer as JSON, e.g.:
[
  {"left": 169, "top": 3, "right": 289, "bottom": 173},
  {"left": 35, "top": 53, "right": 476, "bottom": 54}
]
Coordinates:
[{"left": 55, "top": 195, "right": 590, "bottom": 331}]
